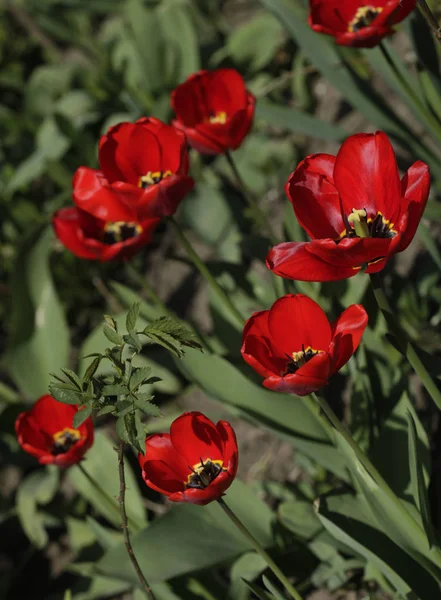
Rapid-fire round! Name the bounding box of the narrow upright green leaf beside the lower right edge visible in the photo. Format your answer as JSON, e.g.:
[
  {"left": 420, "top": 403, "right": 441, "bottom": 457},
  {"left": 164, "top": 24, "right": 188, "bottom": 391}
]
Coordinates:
[{"left": 407, "top": 411, "right": 436, "bottom": 548}]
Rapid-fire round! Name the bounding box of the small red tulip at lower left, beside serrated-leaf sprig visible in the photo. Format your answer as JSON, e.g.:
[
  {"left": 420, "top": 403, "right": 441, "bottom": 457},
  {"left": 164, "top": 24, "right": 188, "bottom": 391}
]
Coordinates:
[{"left": 15, "top": 395, "right": 93, "bottom": 468}]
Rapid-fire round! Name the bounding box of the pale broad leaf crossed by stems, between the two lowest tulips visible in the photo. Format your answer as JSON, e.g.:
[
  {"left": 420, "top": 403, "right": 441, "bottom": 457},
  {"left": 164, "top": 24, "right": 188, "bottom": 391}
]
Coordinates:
[{"left": 67, "top": 431, "right": 147, "bottom": 531}]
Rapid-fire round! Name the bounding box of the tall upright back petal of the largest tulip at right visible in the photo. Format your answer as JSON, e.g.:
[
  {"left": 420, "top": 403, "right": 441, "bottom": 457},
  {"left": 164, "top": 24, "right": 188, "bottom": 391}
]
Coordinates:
[{"left": 334, "top": 131, "right": 401, "bottom": 223}]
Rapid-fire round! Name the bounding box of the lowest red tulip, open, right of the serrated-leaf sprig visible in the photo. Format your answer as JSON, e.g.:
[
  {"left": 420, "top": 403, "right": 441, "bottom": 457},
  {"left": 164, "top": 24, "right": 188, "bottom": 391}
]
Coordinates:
[{"left": 138, "top": 412, "right": 238, "bottom": 505}]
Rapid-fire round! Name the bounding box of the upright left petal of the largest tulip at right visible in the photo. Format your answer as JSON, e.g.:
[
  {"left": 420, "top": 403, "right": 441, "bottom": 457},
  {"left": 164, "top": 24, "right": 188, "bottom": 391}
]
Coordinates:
[{"left": 285, "top": 154, "right": 346, "bottom": 239}]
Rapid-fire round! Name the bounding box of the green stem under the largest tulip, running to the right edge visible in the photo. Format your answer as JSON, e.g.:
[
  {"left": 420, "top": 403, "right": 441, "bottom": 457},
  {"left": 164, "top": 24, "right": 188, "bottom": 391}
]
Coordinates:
[{"left": 370, "top": 273, "right": 441, "bottom": 410}]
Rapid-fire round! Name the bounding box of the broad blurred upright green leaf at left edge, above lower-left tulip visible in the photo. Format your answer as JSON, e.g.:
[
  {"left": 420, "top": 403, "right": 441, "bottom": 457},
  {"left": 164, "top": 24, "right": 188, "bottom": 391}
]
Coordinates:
[{"left": 4, "top": 228, "right": 69, "bottom": 399}]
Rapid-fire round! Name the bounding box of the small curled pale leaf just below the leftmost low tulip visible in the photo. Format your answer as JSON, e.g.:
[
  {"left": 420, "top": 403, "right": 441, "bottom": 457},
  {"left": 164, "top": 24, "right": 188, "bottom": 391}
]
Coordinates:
[{"left": 17, "top": 466, "right": 59, "bottom": 549}]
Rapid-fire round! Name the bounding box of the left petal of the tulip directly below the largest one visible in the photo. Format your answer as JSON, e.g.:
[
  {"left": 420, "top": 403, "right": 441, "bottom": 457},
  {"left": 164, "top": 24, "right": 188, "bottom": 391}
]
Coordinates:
[{"left": 241, "top": 310, "right": 286, "bottom": 377}]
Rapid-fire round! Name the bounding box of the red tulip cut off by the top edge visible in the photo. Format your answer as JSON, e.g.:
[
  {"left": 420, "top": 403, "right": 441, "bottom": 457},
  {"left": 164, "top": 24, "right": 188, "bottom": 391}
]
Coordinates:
[{"left": 308, "top": 0, "right": 416, "bottom": 48}]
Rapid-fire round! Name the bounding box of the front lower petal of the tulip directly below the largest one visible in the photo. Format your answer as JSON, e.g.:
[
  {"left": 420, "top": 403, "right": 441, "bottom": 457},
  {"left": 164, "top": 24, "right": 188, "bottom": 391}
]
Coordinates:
[{"left": 263, "top": 352, "right": 332, "bottom": 396}]
